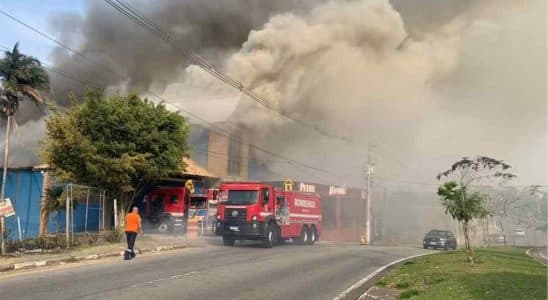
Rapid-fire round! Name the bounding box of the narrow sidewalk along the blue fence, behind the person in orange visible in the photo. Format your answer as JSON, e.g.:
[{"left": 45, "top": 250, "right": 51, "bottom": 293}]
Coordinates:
[{"left": 0, "top": 234, "right": 188, "bottom": 272}]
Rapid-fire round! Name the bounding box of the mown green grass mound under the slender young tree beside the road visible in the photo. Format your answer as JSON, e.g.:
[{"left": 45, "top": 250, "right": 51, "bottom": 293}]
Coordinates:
[{"left": 377, "top": 247, "right": 547, "bottom": 299}]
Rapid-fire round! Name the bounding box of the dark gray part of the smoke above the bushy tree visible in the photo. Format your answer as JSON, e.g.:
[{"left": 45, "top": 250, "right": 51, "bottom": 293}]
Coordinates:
[{"left": 47, "top": 0, "right": 322, "bottom": 103}]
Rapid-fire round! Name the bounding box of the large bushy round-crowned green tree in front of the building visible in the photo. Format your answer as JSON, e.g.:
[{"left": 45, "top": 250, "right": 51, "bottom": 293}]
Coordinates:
[{"left": 42, "top": 91, "right": 189, "bottom": 226}]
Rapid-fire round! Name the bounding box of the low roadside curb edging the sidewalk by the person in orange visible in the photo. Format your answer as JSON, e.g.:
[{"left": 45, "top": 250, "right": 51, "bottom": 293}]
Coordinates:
[{"left": 0, "top": 244, "right": 188, "bottom": 273}]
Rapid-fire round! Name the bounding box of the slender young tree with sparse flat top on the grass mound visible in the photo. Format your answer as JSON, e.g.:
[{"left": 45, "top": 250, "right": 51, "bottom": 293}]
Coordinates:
[{"left": 436, "top": 156, "right": 516, "bottom": 263}]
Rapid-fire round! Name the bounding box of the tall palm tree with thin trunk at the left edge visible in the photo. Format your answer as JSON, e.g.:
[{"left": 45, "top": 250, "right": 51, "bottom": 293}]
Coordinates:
[{"left": 0, "top": 43, "right": 49, "bottom": 254}]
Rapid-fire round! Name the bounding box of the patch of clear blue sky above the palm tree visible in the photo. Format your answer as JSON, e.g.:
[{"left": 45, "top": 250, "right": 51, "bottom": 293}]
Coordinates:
[{"left": 0, "top": 0, "right": 86, "bottom": 63}]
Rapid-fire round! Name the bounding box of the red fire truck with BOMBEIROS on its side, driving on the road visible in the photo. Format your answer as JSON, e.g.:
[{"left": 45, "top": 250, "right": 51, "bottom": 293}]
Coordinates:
[{"left": 215, "top": 182, "right": 322, "bottom": 248}]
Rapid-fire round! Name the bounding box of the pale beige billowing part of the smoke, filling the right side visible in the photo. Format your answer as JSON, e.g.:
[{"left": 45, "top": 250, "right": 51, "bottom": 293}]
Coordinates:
[{"left": 162, "top": 1, "right": 546, "bottom": 184}]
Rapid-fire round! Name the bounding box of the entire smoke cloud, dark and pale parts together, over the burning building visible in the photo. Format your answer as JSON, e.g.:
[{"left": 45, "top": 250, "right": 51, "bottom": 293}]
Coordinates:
[{"left": 6, "top": 0, "right": 546, "bottom": 185}]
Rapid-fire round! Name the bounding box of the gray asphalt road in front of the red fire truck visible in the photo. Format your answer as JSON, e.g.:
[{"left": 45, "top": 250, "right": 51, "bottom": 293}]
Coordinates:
[{"left": 0, "top": 241, "right": 426, "bottom": 300}]
